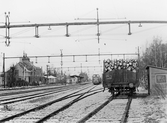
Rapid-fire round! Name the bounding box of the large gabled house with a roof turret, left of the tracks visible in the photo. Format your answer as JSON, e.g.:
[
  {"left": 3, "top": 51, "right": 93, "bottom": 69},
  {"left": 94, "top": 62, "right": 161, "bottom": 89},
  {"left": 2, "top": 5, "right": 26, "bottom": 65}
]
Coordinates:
[{"left": 15, "top": 53, "right": 43, "bottom": 83}]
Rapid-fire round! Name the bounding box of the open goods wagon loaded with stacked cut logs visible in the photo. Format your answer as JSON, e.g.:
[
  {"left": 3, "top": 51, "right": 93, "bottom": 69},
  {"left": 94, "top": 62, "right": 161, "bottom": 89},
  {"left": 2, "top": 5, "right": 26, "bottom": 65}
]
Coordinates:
[{"left": 103, "top": 54, "right": 139, "bottom": 94}]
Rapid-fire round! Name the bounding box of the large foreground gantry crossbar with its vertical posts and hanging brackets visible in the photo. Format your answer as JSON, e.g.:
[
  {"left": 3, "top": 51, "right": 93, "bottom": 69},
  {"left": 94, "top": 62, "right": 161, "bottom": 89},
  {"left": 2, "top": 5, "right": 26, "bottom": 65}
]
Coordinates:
[{"left": 0, "top": 15, "right": 167, "bottom": 46}]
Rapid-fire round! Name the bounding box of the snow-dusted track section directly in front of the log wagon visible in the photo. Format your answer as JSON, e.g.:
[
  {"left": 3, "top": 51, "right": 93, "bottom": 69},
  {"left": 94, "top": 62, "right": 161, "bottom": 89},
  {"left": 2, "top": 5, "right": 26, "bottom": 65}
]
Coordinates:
[{"left": 77, "top": 97, "right": 132, "bottom": 123}]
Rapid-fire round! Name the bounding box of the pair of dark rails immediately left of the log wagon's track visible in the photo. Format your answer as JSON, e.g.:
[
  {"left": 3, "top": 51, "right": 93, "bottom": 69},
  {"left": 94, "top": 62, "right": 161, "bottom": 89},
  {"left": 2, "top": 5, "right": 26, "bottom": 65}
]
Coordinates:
[{"left": 0, "top": 87, "right": 102, "bottom": 122}]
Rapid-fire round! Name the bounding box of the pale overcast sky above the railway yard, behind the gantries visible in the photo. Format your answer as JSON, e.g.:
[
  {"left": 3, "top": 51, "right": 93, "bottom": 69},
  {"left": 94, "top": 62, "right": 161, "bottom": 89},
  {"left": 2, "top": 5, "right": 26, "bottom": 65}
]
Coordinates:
[{"left": 0, "top": 0, "right": 167, "bottom": 75}]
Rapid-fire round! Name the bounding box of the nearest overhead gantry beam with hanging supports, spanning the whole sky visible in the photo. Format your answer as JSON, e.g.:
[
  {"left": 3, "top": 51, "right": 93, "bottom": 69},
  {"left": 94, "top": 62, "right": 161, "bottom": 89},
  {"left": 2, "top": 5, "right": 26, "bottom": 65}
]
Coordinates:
[{"left": 0, "top": 9, "right": 167, "bottom": 46}]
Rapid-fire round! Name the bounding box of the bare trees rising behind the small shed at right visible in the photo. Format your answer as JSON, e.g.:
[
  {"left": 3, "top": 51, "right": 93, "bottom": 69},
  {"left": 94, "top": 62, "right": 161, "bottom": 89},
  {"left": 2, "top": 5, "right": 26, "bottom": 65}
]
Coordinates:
[{"left": 140, "top": 37, "right": 167, "bottom": 88}]
